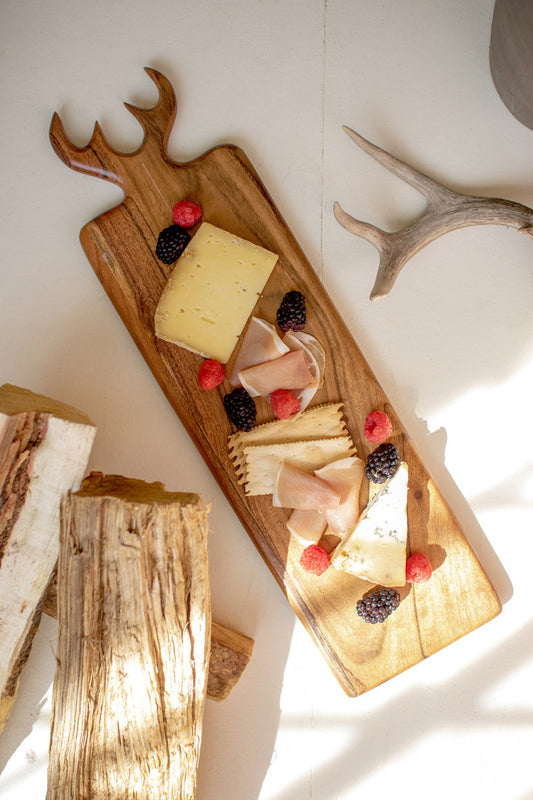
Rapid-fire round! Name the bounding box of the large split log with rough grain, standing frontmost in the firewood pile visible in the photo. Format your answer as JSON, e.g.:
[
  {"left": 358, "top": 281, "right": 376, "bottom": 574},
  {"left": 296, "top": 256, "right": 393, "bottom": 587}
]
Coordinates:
[{"left": 47, "top": 474, "right": 210, "bottom": 800}]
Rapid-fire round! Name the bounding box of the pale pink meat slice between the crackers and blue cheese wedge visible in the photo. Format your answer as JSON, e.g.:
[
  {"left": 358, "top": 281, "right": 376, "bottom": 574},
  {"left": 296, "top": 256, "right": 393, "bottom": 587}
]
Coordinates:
[{"left": 315, "top": 456, "right": 365, "bottom": 535}]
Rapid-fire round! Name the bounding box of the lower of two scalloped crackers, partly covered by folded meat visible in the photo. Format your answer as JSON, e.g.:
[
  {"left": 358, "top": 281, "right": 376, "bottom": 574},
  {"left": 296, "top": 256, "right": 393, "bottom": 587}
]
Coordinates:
[{"left": 244, "top": 436, "right": 355, "bottom": 495}]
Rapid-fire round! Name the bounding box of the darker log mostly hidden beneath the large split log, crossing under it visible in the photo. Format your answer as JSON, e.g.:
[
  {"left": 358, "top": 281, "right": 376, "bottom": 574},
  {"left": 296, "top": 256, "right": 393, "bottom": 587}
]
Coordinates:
[{"left": 43, "top": 580, "right": 254, "bottom": 702}]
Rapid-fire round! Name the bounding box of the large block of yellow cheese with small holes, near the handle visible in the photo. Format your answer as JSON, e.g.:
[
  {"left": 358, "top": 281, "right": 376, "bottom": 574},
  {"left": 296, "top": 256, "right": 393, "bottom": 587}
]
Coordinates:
[{"left": 155, "top": 222, "right": 278, "bottom": 364}]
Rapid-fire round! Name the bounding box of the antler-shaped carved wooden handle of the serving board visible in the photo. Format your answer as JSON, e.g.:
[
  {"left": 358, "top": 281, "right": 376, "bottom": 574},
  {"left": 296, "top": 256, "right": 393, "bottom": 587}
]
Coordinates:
[{"left": 50, "top": 67, "right": 177, "bottom": 194}]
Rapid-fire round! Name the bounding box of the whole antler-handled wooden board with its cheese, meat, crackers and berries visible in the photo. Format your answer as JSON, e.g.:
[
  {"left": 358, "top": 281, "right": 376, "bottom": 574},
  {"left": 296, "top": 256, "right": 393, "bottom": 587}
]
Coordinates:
[{"left": 50, "top": 69, "right": 501, "bottom": 696}]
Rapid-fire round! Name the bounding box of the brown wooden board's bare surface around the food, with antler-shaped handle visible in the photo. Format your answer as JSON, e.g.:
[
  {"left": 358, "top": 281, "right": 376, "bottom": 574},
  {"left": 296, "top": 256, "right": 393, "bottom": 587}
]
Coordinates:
[{"left": 50, "top": 69, "right": 501, "bottom": 695}]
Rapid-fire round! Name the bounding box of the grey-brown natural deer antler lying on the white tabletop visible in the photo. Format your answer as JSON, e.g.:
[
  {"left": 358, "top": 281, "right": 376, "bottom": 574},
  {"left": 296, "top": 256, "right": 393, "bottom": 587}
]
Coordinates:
[{"left": 334, "top": 126, "right": 533, "bottom": 300}]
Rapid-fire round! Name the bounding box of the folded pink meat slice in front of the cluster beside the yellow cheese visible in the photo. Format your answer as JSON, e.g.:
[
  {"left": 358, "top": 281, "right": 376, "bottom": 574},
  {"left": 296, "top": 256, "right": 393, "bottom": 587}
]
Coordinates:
[{"left": 239, "top": 350, "right": 317, "bottom": 398}]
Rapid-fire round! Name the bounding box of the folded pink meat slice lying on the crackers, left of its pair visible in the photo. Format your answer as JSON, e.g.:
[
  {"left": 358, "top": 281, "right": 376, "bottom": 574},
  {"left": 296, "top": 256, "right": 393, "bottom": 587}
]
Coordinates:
[{"left": 272, "top": 462, "right": 340, "bottom": 511}]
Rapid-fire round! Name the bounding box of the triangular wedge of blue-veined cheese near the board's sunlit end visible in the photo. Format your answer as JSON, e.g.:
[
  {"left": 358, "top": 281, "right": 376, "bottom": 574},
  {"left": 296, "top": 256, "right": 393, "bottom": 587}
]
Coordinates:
[{"left": 331, "top": 462, "right": 408, "bottom": 586}]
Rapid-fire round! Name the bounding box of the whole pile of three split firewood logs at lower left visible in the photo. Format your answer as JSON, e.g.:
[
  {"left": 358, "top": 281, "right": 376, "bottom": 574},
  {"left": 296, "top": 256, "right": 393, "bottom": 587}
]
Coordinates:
[{"left": 0, "top": 385, "right": 254, "bottom": 800}]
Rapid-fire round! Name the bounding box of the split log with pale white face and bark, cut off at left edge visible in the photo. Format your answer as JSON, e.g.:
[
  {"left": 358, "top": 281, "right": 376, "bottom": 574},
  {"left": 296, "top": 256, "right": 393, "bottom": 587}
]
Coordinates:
[{"left": 0, "top": 384, "right": 96, "bottom": 733}]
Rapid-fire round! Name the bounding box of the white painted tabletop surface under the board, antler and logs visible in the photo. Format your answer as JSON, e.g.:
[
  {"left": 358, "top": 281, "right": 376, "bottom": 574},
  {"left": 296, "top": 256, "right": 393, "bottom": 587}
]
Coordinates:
[{"left": 0, "top": 0, "right": 533, "bottom": 800}]
